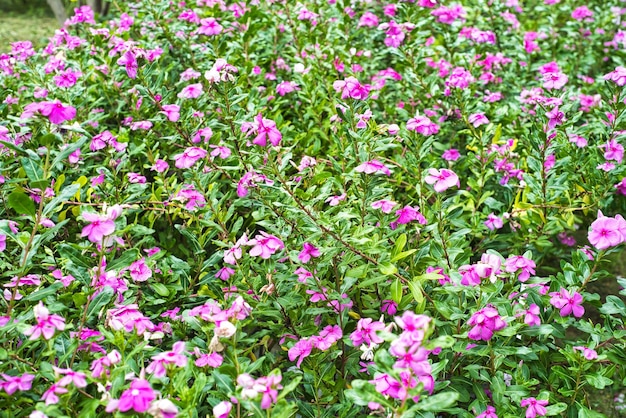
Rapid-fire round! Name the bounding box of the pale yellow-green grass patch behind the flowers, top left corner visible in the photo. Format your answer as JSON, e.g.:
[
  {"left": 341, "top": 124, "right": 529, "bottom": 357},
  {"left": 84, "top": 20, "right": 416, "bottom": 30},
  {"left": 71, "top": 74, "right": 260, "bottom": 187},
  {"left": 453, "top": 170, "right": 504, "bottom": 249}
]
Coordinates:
[{"left": 0, "top": 13, "right": 59, "bottom": 53}]
